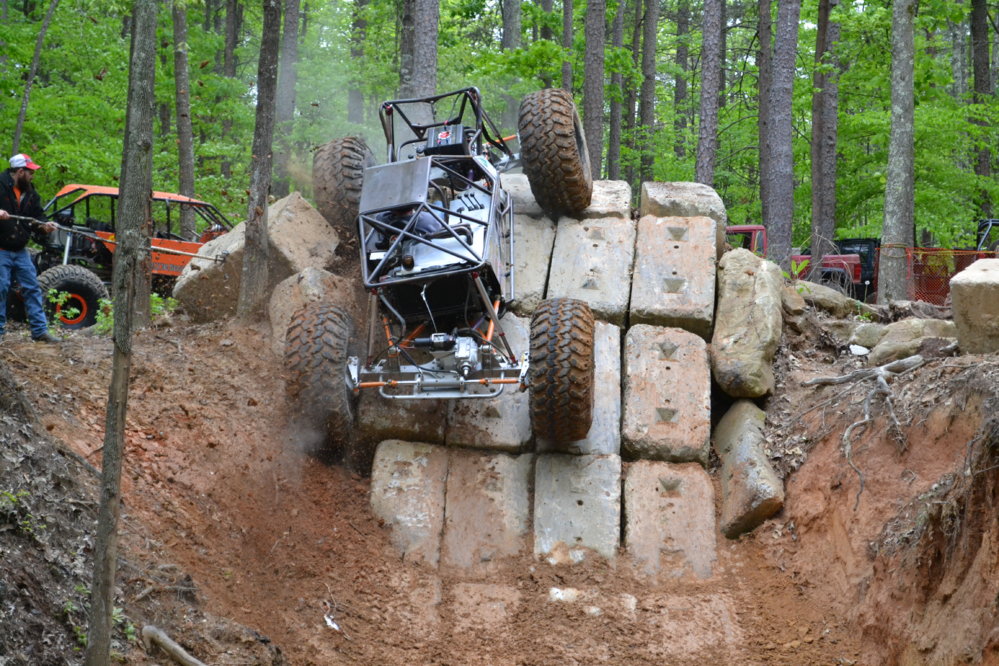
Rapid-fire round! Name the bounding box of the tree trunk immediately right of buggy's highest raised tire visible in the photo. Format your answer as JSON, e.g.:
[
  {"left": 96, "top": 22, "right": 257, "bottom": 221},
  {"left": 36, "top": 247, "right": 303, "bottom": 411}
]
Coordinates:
[{"left": 584, "top": 0, "right": 607, "bottom": 179}]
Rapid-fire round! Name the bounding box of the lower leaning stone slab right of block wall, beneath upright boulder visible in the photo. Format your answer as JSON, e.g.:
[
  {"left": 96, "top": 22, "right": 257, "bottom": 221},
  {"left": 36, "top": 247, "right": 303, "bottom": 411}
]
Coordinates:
[{"left": 714, "top": 400, "right": 784, "bottom": 539}]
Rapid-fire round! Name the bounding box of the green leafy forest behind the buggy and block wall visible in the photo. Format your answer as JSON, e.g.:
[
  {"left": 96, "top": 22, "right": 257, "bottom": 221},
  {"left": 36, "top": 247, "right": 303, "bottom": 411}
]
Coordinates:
[{"left": 0, "top": 0, "right": 999, "bottom": 248}]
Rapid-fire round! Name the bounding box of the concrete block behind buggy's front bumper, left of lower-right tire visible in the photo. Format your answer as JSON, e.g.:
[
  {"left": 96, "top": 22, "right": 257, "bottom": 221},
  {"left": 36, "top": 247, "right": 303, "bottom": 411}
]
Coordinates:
[{"left": 448, "top": 313, "right": 531, "bottom": 453}]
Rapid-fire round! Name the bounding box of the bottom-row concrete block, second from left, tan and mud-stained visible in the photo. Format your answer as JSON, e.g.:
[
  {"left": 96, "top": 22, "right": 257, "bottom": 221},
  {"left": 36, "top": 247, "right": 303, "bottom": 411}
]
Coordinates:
[{"left": 441, "top": 451, "right": 534, "bottom": 574}]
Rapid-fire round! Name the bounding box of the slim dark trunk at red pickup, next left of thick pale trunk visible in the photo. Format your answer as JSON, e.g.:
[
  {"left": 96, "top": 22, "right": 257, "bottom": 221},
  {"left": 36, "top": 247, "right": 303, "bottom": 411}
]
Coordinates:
[{"left": 809, "top": 0, "right": 839, "bottom": 281}]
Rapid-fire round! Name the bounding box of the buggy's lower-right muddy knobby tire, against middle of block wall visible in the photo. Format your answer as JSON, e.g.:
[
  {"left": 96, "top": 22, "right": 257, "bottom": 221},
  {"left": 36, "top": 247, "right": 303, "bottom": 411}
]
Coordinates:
[{"left": 530, "top": 298, "right": 594, "bottom": 443}]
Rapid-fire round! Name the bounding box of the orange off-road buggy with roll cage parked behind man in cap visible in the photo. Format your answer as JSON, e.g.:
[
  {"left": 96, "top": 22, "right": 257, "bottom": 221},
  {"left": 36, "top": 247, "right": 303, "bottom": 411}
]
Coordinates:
[{"left": 25, "top": 184, "right": 232, "bottom": 328}]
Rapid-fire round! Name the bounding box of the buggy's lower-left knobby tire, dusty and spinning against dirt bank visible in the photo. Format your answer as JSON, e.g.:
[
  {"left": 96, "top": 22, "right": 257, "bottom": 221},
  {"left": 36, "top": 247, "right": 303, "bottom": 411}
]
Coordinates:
[{"left": 284, "top": 303, "right": 355, "bottom": 460}]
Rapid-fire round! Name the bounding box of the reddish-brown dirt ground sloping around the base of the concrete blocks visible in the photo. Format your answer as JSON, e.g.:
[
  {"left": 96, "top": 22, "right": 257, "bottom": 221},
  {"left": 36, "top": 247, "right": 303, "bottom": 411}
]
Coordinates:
[{"left": 0, "top": 312, "right": 994, "bottom": 665}]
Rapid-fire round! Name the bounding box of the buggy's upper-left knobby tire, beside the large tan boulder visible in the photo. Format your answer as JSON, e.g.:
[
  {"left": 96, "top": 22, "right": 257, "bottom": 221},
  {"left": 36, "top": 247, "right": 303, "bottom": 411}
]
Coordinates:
[{"left": 312, "top": 136, "right": 375, "bottom": 244}]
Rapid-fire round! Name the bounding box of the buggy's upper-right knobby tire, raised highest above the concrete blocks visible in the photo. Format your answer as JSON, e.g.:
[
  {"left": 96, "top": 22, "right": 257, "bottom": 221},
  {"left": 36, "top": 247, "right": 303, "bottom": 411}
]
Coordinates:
[{"left": 517, "top": 88, "right": 593, "bottom": 217}]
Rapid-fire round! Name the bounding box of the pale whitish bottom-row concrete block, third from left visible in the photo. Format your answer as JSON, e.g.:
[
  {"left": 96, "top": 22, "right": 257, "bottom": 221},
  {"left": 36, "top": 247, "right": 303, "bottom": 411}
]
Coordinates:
[{"left": 534, "top": 453, "right": 621, "bottom": 564}]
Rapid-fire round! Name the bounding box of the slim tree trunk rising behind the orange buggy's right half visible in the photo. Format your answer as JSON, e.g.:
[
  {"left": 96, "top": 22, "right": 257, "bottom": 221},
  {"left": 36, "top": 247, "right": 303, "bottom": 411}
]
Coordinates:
[{"left": 172, "top": 0, "right": 198, "bottom": 240}]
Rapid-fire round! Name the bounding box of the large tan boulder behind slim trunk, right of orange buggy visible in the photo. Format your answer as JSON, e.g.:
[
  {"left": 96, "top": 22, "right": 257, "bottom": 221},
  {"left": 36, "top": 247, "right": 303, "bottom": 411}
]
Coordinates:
[{"left": 173, "top": 192, "right": 339, "bottom": 322}]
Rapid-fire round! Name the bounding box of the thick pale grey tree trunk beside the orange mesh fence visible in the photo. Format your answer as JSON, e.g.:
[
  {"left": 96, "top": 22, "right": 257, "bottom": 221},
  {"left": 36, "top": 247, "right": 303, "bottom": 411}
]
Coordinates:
[{"left": 878, "top": 0, "right": 915, "bottom": 303}]
